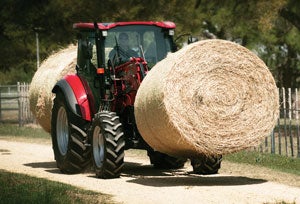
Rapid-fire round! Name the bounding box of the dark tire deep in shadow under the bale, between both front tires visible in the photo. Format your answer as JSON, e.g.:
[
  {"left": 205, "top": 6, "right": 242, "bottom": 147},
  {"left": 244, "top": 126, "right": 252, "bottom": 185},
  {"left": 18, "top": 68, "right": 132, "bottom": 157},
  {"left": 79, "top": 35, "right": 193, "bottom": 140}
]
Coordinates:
[{"left": 147, "top": 150, "right": 187, "bottom": 169}]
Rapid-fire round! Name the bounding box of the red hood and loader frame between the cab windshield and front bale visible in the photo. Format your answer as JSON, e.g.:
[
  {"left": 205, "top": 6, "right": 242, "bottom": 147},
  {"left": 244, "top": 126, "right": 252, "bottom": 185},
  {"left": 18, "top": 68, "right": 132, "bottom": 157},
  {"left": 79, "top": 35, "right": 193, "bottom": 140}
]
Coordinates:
[{"left": 111, "top": 57, "right": 148, "bottom": 112}]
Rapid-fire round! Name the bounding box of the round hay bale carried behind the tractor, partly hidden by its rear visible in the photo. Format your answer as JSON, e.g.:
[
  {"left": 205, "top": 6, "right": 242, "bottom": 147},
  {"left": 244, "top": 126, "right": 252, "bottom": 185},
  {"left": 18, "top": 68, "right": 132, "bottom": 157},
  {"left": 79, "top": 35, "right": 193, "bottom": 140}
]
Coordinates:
[{"left": 29, "top": 45, "right": 77, "bottom": 132}]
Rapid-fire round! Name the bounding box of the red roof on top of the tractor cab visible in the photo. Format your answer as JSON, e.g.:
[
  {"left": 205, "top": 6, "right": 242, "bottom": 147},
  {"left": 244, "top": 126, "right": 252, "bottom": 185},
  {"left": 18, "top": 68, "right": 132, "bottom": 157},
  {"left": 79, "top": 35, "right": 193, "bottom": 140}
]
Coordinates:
[{"left": 73, "top": 21, "right": 176, "bottom": 30}]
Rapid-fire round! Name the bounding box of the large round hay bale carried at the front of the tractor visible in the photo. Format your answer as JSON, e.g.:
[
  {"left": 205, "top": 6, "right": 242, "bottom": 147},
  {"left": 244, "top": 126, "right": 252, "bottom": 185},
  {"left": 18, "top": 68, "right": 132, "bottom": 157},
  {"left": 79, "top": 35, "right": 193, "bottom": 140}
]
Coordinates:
[{"left": 134, "top": 39, "right": 279, "bottom": 158}]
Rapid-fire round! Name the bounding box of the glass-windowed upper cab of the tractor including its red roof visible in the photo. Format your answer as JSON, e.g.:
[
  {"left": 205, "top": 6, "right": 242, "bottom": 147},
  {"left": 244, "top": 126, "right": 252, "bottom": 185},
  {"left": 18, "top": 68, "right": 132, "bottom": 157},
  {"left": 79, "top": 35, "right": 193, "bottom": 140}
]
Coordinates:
[{"left": 73, "top": 22, "right": 176, "bottom": 72}]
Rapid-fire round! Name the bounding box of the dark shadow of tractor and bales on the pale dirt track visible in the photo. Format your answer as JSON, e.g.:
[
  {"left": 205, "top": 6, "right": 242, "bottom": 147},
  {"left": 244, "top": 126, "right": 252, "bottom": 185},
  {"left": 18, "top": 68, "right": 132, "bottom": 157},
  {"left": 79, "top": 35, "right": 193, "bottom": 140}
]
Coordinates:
[{"left": 24, "top": 161, "right": 267, "bottom": 187}]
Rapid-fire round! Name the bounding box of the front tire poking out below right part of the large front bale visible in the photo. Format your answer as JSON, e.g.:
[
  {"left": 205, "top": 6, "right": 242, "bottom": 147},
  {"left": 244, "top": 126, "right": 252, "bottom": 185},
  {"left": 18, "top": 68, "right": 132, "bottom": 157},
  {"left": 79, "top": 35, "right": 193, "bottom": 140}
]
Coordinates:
[{"left": 191, "top": 156, "right": 222, "bottom": 175}]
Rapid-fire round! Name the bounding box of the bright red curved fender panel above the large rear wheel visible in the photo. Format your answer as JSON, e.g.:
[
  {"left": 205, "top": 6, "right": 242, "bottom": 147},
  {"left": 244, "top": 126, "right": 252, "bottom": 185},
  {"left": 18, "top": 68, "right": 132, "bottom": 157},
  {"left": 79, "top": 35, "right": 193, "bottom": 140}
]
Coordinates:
[{"left": 64, "top": 74, "right": 91, "bottom": 121}]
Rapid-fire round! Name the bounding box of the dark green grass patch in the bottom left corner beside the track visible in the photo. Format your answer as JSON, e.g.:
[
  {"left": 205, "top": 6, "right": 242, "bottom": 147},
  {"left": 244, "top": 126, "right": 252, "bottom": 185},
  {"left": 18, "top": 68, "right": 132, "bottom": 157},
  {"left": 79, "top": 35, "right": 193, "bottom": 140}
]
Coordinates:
[{"left": 0, "top": 170, "right": 113, "bottom": 204}]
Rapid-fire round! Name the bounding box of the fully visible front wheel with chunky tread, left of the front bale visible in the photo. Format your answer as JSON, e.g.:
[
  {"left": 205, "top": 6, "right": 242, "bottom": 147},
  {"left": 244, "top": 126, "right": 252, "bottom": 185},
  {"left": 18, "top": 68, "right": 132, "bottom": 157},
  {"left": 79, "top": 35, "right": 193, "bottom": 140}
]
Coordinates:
[{"left": 90, "top": 111, "right": 125, "bottom": 179}]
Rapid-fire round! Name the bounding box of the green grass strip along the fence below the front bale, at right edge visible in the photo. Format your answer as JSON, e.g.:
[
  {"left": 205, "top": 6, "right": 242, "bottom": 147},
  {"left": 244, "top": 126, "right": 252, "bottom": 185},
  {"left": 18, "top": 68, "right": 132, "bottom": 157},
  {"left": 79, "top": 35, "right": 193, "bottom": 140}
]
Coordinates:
[{"left": 224, "top": 151, "right": 300, "bottom": 176}]
